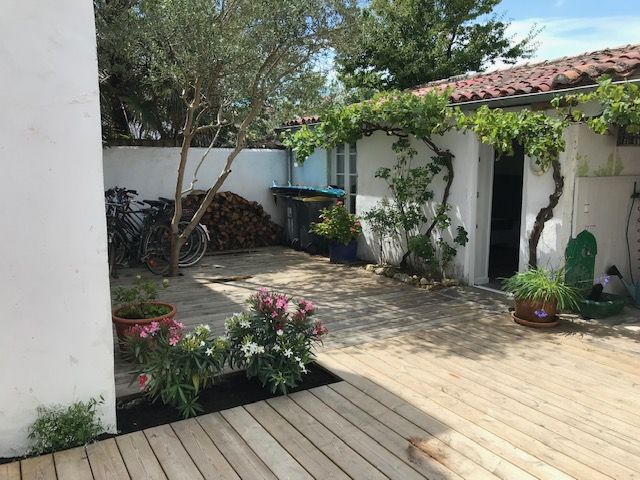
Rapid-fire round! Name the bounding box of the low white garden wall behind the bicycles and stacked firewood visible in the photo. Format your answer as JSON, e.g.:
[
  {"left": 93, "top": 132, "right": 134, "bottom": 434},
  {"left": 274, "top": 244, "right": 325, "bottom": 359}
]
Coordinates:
[{"left": 104, "top": 147, "right": 287, "bottom": 225}]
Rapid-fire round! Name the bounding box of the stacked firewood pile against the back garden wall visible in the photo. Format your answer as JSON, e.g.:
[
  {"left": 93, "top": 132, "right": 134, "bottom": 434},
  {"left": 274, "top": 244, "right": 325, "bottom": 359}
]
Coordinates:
[{"left": 183, "top": 191, "right": 282, "bottom": 251}]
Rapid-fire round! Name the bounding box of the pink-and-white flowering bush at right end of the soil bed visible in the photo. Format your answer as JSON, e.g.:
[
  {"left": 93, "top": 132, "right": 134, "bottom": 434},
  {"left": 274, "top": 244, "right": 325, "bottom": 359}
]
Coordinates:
[{"left": 226, "top": 289, "right": 327, "bottom": 393}]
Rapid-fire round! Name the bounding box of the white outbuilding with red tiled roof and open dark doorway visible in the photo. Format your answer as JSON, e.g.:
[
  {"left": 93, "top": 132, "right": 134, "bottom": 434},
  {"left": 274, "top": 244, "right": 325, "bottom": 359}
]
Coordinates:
[{"left": 287, "top": 45, "right": 640, "bottom": 285}]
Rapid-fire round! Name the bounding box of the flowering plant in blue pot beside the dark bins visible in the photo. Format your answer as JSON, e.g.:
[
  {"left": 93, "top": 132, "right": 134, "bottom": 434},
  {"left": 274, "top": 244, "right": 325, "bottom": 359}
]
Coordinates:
[{"left": 311, "top": 202, "right": 362, "bottom": 263}]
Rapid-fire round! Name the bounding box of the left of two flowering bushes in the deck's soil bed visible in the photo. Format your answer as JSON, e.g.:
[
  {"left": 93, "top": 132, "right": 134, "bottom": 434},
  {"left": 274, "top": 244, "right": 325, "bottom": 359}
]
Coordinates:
[{"left": 125, "top": 319, "right": 227, "bottom": 418}]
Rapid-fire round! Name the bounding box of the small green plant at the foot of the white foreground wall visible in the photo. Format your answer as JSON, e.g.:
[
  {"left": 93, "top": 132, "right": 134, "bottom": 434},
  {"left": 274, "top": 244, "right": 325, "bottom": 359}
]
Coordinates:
[{"left": 29, "top": 397, "right": 105, "bottom": 455}]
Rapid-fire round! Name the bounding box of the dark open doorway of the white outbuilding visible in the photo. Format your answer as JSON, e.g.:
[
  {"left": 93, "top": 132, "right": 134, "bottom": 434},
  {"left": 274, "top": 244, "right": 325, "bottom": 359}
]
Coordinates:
[{"left": 489, "top": 145, "right": 524, "bottom": 289}]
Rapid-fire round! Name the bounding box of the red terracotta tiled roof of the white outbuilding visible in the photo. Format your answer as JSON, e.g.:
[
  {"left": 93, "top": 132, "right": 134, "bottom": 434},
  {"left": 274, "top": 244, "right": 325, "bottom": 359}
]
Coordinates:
[{"left": 412, "top": 45, "right": 640, "bottom": 103}]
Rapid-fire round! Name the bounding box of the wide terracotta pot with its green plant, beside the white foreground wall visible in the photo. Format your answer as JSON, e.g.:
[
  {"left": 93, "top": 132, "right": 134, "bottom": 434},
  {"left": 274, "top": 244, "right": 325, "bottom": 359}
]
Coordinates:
[{"left": 111, "top": 275, "right": 176, "bottom": 341}]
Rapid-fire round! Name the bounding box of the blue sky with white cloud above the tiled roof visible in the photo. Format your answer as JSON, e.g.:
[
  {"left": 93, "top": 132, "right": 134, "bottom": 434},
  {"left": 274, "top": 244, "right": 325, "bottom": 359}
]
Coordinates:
[{"left": 496, "top": 0, "right": 640, "bottom": 61}]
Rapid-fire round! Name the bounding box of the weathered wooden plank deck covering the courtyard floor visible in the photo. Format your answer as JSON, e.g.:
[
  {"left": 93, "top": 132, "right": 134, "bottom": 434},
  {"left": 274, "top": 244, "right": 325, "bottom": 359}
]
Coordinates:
[{"left": 5, "top": 249, "right": 640, "bottom": 480}]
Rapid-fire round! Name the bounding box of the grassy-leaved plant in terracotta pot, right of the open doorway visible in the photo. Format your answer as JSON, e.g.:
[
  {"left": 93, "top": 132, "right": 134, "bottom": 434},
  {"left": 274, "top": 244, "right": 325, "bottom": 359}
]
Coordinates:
[{"left": 503, "top": 268, "right": 579, "bottom": 328}]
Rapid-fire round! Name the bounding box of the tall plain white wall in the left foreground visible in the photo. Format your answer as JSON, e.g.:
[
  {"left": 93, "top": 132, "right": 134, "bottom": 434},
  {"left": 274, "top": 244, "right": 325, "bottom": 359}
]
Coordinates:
[{"left": 0, "top": 0, "right": 115, "bottom": 457}]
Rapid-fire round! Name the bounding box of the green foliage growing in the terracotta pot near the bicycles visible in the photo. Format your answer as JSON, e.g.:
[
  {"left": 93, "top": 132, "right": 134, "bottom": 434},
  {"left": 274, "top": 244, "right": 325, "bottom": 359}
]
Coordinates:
[{"left": 111, "top": 275, "right": 170, "bottom": 319}]
